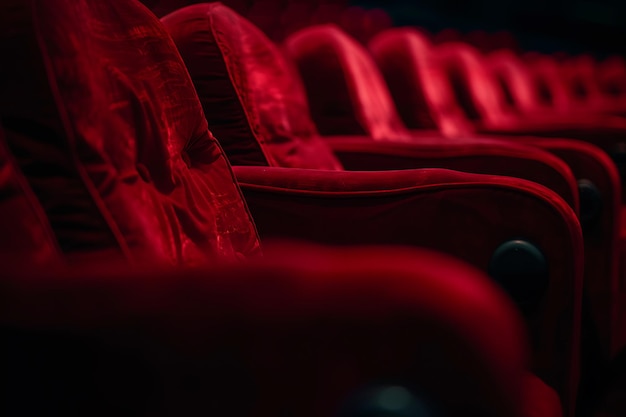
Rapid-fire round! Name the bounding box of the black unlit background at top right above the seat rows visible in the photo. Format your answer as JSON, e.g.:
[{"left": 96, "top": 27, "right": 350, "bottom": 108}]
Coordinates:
[{"left": 351, "top": 0, "right": 626, "bottom": 57}]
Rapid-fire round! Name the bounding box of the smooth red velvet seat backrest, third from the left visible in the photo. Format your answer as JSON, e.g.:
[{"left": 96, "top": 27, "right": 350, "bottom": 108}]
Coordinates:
[{"left": 285, "top": 24, "right": 410, "bottom": 141}]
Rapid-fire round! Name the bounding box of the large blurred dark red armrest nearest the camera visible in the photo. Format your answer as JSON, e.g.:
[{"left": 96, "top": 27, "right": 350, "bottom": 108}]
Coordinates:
[{"left": 0, "top": 242, "right": 536, "bottom": 417}]
